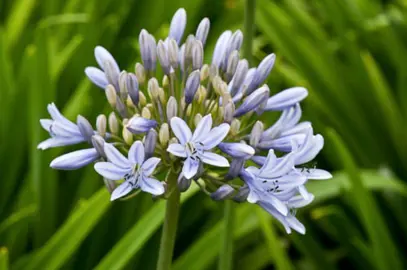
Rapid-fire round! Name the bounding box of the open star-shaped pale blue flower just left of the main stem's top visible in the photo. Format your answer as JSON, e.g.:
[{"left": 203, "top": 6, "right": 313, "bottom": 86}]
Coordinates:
[{"left": 95, "top": 141, "right": 165, "bottom": 201}]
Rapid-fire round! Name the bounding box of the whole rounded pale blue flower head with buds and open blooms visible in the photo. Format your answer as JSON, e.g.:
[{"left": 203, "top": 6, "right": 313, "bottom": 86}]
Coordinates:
[{"left": 38, "top": 9, "right": 331, "bottom": 233}]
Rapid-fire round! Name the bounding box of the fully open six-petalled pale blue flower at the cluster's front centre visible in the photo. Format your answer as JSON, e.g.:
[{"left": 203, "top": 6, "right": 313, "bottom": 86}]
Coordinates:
[{"left": 167, "top": 114, "right": 230, "bottom": 179}]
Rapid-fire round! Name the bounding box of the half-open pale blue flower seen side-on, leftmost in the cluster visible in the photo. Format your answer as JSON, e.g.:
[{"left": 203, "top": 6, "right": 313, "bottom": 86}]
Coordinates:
[{"left": 38, "top": 103, "right": 94, "bottom": 150}]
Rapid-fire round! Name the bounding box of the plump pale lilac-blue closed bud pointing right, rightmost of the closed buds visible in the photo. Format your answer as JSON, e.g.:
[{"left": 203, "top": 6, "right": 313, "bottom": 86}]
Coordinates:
[{"left": 264, "top": 87, "right": 308, "bottom": 111}]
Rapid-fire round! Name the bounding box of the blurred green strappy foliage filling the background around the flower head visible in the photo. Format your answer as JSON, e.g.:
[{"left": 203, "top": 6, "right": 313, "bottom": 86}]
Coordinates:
[{"left": 0, "top": 0, "right": 407, "bottom": 270}]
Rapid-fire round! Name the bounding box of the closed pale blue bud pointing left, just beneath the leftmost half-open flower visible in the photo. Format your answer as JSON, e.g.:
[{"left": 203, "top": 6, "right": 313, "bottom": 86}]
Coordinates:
[{"left": 50, "top": 148, "right": 99, "bottom": 170}]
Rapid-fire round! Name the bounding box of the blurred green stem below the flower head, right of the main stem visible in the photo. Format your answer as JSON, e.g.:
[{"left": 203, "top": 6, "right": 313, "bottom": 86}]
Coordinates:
[{"left": 218, "top": 200, "right": 235, "bottom": 270}]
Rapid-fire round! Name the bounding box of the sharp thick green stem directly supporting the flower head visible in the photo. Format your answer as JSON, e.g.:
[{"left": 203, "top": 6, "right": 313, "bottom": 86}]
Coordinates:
[{"left": 157, "top": 173, "right": 180, "bottom": 270}]
